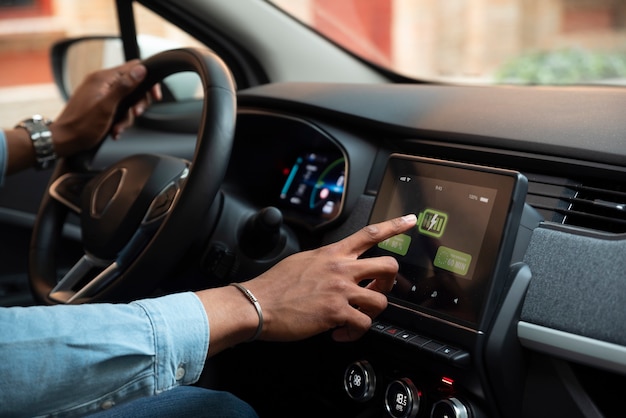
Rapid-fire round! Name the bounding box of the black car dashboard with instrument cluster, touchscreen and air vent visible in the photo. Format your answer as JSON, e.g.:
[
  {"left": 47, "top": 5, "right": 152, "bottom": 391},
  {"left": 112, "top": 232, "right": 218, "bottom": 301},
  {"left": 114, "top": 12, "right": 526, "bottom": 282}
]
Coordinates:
[{"left": 201, "top": 83, "right": 626, "bottom": 418}]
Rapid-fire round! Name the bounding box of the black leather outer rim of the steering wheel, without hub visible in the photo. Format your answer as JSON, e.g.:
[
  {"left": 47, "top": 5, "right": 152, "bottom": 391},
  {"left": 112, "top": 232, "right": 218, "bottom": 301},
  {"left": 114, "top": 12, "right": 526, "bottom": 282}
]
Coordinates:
[{"left": 28, "top": 48, "right": 236, "bottom": 304}]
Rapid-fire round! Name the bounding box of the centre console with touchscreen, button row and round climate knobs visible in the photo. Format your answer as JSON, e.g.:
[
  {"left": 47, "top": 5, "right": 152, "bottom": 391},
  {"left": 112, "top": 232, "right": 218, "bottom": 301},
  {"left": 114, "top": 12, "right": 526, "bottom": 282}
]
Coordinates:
[{"left": 343, "top": 154, "right": 539, "bottom": 418}]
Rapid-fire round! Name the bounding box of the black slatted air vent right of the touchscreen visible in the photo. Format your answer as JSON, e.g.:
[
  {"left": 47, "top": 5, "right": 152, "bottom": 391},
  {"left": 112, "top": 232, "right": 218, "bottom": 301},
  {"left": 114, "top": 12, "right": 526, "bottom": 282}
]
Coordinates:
[{"left": 526, "top": 174, "right": 626, "bottom": 233}]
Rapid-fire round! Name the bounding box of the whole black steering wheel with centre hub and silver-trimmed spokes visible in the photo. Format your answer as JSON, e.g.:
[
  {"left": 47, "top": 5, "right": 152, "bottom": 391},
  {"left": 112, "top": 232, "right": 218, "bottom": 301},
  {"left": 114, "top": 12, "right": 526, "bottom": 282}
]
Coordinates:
[{"left": 28, "top": 48, "right": 236, "bottom": 304}]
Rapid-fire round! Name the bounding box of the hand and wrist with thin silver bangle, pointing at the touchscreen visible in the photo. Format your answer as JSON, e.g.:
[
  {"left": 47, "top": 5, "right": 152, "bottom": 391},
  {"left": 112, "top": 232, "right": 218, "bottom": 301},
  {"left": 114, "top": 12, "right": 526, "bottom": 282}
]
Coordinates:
[{"left": 198, "top": 215, "right": 417, "bottom": 355}]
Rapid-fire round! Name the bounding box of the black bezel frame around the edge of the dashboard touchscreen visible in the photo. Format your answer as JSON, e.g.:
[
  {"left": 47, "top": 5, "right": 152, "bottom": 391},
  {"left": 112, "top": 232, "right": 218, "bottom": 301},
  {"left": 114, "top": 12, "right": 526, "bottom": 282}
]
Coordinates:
[{"left": 366, "top": 154, "right": 527, "bottom": 331}]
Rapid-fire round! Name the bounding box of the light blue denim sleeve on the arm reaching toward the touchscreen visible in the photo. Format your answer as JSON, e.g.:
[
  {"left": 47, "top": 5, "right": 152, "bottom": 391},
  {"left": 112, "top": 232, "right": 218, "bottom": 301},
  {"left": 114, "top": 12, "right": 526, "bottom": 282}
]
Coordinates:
[{"left": 0, "top": 293, "right": 209, "bottom": 417}]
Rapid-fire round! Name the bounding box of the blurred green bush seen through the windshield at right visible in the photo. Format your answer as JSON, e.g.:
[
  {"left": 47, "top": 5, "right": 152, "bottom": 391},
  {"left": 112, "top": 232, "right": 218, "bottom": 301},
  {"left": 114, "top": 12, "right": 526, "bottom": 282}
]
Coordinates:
[{"left": 496, "top": 48, "right": 626, "bottom": 85}]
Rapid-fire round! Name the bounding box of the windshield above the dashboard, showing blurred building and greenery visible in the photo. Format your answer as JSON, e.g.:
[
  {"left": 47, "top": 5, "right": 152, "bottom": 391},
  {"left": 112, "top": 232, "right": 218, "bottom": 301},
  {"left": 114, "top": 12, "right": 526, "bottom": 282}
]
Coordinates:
[{"left": 270, "top": 0, "right": 626, "bottom": 85}]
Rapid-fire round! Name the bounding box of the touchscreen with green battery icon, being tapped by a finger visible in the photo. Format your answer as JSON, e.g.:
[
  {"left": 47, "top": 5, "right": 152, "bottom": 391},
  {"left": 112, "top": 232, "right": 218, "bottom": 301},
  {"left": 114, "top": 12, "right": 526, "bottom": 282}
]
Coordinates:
[{"left": 367, "top": 155, "right": 522, "bottom": 328}]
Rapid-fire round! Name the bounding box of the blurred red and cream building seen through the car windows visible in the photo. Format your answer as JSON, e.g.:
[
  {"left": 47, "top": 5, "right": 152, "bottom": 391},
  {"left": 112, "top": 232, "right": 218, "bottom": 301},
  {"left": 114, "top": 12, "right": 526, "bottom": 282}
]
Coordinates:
[{"left": 0, "top": 0, "right": 626, "bottom": 123}]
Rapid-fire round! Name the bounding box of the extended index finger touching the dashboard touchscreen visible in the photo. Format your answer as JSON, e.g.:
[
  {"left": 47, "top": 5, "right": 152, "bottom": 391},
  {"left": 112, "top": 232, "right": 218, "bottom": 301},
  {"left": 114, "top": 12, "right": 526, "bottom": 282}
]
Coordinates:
[{"left": 343, "top": 214, "right": 417, "bottom": 256}]
